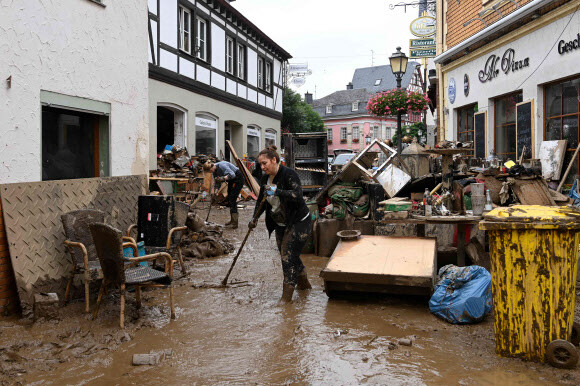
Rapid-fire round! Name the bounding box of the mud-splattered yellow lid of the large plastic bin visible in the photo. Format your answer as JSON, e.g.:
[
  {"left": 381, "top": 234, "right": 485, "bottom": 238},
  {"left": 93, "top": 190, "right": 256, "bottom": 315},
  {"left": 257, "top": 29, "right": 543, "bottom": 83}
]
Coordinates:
[{"left": 479, "top": 205, "right": 580, "bottom": 230}]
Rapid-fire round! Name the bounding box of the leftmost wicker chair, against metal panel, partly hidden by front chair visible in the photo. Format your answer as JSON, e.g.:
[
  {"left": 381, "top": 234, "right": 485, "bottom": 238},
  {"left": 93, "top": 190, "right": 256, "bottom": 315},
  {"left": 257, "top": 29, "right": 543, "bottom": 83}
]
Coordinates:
[{"left": 61, "top": 209, "right": 105, "bottom": 312}]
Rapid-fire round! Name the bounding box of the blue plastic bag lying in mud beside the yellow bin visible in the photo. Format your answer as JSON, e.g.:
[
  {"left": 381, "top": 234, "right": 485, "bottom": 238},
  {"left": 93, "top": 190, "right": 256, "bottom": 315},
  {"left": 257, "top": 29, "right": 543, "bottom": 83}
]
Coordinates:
[{"left": 429, "top": 265, "right": 492, "bottom": 324}]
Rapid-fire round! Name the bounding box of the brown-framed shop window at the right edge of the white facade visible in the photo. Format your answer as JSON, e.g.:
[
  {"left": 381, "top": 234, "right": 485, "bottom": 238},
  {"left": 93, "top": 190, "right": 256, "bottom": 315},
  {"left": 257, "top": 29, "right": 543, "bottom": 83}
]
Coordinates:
[{"left": 544, "top": 77, "right": 580, "bottom": 179}]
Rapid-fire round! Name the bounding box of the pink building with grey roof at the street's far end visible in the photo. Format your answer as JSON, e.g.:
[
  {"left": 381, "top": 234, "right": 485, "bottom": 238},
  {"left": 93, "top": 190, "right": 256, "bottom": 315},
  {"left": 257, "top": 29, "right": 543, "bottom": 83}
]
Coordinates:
[{"left": 305, "top": 62, "right": 422, "bottom": 154}]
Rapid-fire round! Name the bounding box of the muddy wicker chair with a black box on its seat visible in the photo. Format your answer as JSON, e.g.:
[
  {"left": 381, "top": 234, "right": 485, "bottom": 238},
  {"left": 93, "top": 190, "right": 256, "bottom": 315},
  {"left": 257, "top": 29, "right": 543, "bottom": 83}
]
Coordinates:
[{"left": 126, "top": 201, "right": 189, "bottom": 275}]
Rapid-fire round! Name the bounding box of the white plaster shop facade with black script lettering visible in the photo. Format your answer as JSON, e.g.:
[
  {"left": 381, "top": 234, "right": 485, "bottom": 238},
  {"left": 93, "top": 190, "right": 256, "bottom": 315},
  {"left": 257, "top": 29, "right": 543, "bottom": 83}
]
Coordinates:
[{"left": 441, "top": 3, "right": 580, "bottom": 157}]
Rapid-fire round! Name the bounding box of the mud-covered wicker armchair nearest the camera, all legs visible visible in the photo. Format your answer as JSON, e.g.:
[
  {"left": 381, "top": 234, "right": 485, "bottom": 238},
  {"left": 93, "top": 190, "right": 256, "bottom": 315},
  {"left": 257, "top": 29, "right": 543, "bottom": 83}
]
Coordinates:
[{"left": 90, "top": 224, "right": 175, "bottom": 328}]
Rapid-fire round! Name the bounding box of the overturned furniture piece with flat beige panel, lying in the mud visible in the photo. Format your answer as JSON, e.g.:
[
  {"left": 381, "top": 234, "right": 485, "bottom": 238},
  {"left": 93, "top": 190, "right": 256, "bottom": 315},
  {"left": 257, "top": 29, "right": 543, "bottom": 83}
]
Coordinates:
[{"left": 320, "top": 236, "right": 437, "bottom": 297}]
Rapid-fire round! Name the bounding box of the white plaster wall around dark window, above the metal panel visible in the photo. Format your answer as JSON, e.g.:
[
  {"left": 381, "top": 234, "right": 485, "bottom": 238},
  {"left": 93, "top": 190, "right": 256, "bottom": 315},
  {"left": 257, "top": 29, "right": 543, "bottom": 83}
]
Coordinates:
[{"left": 0, "top": 0, "right": 149, "bottom": 183}]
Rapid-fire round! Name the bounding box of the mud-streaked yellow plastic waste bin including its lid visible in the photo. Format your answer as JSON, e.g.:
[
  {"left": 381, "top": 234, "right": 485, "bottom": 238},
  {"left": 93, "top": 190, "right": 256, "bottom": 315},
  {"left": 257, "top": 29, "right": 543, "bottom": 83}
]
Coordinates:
[{"left": 479, "top": 205, "right": 580, "bottom": 362}]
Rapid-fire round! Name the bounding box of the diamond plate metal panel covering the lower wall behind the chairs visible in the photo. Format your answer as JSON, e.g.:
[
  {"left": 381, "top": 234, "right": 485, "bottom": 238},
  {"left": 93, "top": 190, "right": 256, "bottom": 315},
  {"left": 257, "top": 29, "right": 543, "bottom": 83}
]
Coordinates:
[{"left": 0, "top": 175, "right": 147, "bottom": 309}]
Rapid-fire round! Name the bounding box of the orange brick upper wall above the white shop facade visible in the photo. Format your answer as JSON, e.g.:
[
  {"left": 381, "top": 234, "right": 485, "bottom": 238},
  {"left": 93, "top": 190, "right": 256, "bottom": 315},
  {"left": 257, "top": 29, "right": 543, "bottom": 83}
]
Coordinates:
[{"left": 445, "top": 0, "right": 532, "bottom": 49}]
